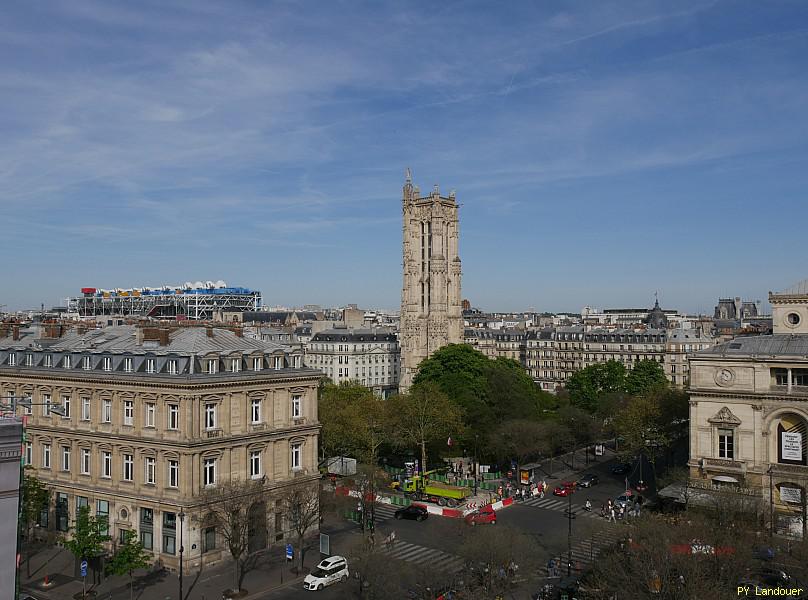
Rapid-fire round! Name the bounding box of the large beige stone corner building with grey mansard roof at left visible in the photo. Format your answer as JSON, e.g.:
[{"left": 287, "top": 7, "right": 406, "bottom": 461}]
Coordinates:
[{"left": 0, "top": 326, "right": 321, "bottom": 570}]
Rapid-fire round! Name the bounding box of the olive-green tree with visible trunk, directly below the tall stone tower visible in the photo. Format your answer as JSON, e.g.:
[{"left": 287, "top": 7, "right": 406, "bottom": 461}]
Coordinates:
[{"left": 388, "top": 383, "right": 463, "bottom": 472}]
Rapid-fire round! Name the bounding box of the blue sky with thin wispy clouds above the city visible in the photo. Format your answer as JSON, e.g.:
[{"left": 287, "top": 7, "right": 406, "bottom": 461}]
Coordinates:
[{"left": 0, "top": 0, "right": 808, "bottom": 313}]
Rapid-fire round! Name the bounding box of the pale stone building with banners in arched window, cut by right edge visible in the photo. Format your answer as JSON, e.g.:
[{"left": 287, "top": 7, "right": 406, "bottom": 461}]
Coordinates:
[{"left": 689, "top": 282, "right": 808, "bottom": 535}]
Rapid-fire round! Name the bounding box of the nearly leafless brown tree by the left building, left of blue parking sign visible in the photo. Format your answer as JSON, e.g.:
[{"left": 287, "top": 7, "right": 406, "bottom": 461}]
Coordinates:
[{"left": 194, "top": 479, "right": 268, "bottom": 592}]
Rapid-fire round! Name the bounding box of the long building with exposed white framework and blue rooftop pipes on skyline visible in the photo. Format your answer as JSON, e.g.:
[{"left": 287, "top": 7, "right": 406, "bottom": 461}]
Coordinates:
[{"left": 68, "top": 281, "right": 261, "bottom": 320}]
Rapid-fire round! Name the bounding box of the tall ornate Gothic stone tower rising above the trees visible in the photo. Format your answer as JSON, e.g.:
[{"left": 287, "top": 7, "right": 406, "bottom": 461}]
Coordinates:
[{"left": 399, "top": 169, "right": 463, "bottom": 392}]
